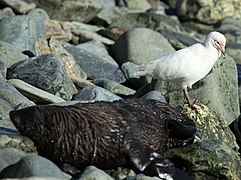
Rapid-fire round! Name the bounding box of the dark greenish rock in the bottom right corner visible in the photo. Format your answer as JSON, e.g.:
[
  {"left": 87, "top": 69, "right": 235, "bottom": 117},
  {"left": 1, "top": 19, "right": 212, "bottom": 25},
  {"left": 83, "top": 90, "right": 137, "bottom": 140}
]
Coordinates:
[{"left": 166, "top": 139, "right": 241, "bottom": 180}]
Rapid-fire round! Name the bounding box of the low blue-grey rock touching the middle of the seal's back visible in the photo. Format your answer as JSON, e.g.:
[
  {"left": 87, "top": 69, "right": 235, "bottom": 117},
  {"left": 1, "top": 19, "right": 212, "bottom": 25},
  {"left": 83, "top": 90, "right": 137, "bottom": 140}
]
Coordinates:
[{"left": 73, "top": 86, "right": 121, "bottom": 102}]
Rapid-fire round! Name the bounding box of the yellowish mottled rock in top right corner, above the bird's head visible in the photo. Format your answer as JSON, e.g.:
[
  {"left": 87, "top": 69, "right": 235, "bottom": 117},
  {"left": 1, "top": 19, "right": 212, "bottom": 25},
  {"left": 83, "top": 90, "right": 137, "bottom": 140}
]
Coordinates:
[{"left": 168, "top": 0, "right": 241, "bottom": 24}]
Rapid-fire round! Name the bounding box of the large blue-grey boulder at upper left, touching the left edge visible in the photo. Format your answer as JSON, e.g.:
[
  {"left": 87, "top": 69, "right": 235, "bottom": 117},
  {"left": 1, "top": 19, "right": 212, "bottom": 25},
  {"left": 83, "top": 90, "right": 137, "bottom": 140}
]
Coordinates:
[{"left": 0, "top": 15, "right": 46, "bottom": 53}]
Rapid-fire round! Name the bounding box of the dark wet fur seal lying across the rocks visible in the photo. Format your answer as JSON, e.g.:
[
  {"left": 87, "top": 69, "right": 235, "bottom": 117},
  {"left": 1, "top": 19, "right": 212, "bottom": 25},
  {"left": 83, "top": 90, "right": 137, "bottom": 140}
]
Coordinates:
[{"left": 10, "top": 99, "right": 196, "bottom": 178}]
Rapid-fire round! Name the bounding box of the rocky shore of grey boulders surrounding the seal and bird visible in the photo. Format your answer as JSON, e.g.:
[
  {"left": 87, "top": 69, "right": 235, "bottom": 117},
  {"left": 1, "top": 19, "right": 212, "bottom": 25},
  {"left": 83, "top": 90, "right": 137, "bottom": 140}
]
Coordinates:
[{"left": 0, "top": 0, "right": 241, "bottom": 180}]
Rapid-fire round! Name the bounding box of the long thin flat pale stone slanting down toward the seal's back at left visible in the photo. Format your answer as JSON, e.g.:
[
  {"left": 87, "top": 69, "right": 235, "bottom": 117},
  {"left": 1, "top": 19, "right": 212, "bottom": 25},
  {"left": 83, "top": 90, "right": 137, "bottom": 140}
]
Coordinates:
[{"left": 8, "top": 79, "right": 65, "bottom": 104}]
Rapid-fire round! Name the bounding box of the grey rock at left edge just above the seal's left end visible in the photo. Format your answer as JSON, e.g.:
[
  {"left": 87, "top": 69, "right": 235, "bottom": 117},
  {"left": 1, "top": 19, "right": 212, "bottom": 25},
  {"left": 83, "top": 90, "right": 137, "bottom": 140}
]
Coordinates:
[{"left": 0, "top": 80, "right": 35, "bottom": 108}]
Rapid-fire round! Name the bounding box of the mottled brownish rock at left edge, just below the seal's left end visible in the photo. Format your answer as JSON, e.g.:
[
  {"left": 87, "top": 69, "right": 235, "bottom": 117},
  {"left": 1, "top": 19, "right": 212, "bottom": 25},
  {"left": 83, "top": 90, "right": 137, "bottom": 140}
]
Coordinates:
[{"left": 0, "top": 135, "right": 37, "bottom": 154}]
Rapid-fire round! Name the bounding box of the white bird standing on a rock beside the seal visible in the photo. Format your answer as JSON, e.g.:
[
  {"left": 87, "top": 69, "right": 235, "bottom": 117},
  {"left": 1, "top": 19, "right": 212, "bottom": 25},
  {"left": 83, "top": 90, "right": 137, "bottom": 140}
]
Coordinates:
[{"left": 135, "top": 31, "right": 226, "bottom": 105}]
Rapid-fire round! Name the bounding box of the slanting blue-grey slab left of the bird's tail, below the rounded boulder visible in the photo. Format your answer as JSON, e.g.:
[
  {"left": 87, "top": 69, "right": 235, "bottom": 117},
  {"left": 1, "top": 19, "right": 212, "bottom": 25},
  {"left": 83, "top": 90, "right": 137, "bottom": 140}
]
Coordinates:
[{"left": 66, "top": 46, "right": 126, "bottom": 83}]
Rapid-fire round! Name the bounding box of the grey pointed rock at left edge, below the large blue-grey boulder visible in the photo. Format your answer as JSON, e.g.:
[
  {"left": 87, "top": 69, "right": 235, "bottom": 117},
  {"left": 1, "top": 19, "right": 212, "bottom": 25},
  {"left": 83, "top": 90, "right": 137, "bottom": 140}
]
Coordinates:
[{"left": 0, "top": 41, "right": 28, "bottom": 68}]
